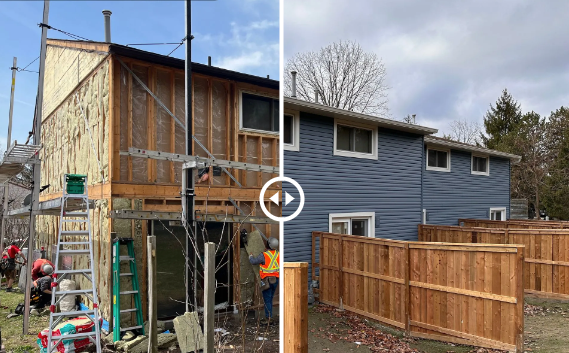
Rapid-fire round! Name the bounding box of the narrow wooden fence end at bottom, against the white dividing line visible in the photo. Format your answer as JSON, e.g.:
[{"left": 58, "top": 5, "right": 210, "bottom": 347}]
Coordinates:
[{"left": 281, "top": 262, "right": 308, "bottom": 353}]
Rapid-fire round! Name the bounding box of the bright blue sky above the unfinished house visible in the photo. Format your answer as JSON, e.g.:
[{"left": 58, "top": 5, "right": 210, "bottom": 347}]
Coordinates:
[{"left": 0, "top": 0, "right": 279, "bottom": 150}]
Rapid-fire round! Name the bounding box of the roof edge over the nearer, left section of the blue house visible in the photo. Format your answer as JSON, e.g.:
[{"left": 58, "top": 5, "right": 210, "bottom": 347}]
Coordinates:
[{"left": 284, "top": 97, "right": 438, "bottom": 135}]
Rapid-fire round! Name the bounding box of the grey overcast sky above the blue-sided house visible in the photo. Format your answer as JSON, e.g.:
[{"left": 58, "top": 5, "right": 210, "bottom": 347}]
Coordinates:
[{"left": 284, "top": 0, "right": 569, "bottom": 132}]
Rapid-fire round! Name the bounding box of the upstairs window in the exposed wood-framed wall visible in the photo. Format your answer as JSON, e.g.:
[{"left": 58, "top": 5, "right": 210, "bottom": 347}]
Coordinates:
[{"left": 239, "top": 91, "right": 280, "bottom": 135}]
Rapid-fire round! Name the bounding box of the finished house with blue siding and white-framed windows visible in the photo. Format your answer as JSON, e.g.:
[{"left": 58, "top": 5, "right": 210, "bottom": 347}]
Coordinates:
[{"left": 282, "top": 97, "right": 516, "bottom": 262}]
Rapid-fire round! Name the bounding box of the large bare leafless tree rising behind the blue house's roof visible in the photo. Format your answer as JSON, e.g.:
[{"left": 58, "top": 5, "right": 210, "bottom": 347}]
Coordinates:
[{"left": 285, "top": 41, "right": 389, "bottom": 117}]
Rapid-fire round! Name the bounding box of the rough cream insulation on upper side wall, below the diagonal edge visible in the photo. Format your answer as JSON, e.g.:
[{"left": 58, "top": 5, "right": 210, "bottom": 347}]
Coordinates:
[{"left": 40, "top": 58, "right": 109, "bottom": 195}]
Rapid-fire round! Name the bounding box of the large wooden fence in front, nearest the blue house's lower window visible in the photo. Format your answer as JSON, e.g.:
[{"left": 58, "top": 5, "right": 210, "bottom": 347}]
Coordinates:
[{"left": 312, "top": 232, "right": 524, "bottom": 352}]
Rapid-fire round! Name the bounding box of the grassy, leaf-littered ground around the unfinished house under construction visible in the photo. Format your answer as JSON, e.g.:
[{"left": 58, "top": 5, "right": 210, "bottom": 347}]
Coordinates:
[{"left": 0, "top": 286, "right": 279, "bottom": 353}]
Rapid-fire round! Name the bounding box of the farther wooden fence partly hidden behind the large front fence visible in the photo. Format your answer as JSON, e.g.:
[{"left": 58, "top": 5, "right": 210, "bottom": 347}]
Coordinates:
[{"left": 419, "top": 224, "right": 569, "bottom": 299}]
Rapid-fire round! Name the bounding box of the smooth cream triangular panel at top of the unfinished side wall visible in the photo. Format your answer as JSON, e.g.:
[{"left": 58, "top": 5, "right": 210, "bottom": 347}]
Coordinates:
[{"left": 42, "top": 44, "right": 107, "bottom": 120}]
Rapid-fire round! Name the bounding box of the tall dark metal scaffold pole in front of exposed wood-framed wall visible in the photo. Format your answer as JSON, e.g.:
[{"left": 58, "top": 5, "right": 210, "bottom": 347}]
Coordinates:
[{"left": 182, "top": 0, "right": 197, "bottom": 312}]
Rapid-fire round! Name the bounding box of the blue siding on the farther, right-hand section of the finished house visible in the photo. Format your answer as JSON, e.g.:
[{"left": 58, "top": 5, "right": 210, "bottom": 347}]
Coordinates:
[{"left": 423, "top": 149, "right": 510, "bottom": 225}]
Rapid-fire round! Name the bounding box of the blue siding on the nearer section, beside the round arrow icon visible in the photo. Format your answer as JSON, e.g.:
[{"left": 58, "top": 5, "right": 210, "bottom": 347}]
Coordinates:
[{"left": 283, "top": 113, "right": 423, "bottom": 262}]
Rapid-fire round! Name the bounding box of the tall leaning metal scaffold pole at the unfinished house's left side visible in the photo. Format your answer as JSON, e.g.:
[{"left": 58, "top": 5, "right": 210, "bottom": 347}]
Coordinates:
[{"left": 23, "top": 0, "right": 49, "bottom": 335}]
